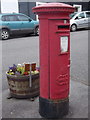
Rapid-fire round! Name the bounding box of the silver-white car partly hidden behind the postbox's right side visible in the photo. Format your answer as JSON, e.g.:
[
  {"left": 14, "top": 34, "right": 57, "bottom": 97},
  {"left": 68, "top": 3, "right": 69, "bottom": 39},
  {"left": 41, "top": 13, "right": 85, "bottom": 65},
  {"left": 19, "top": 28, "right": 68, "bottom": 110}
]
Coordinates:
[{"left": 70, "top": 11, "right": 90, "bottom": 31}]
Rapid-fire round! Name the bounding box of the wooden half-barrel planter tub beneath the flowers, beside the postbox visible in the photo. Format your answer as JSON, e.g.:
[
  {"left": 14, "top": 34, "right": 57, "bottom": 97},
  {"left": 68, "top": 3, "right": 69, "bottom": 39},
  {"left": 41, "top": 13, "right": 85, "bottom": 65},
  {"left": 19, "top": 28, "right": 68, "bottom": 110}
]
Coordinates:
[{"left": 6, "top": 73, "right": 39, "bottom": 98}]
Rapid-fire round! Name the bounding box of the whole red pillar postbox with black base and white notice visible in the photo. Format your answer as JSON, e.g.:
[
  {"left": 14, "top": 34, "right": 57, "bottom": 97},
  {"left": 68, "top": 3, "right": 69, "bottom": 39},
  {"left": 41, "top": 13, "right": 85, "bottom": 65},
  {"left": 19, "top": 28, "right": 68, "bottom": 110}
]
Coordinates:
[{"left": 33, "top": 3, "right": 74, "bottom": 118}]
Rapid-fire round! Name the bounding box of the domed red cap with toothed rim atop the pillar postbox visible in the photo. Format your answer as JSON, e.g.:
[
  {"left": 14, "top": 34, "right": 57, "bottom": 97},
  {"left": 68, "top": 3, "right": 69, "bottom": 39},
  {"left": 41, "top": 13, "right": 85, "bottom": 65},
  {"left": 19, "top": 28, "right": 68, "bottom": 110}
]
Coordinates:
[{"left": 33, "top": 3, "right": 75, "bottom": 14}]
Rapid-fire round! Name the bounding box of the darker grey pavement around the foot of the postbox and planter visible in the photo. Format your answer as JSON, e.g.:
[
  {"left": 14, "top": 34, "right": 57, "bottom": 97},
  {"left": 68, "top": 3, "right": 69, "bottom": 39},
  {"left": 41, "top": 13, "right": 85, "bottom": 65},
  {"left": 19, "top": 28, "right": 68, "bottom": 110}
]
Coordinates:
[{"left": 2, "top": 80, "right": 88, "bottom": 118}]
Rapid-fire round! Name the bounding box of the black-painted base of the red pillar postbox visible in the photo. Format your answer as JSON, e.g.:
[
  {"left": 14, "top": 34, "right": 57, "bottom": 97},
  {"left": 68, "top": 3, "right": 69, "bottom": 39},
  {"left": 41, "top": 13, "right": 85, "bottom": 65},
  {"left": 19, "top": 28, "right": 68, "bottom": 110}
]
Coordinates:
[{"left": 39, "top": 97, "right": 69, "bottom": 118}]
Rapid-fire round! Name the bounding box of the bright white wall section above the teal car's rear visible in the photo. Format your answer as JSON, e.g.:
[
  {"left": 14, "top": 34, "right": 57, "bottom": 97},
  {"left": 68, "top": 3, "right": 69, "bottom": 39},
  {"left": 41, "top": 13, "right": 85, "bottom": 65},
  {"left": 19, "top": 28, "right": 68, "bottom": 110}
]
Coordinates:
[{"left": 1, "top": 0, "right": 19, "bottom": 13}]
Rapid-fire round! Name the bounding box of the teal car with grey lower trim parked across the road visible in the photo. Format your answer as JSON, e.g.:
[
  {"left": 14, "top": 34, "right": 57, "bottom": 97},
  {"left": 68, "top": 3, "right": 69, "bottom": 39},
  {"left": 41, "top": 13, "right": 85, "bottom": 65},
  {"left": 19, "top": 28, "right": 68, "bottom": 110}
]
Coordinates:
[{"left": 0, "top": 13, "right": 39, "bottom": 40}]
